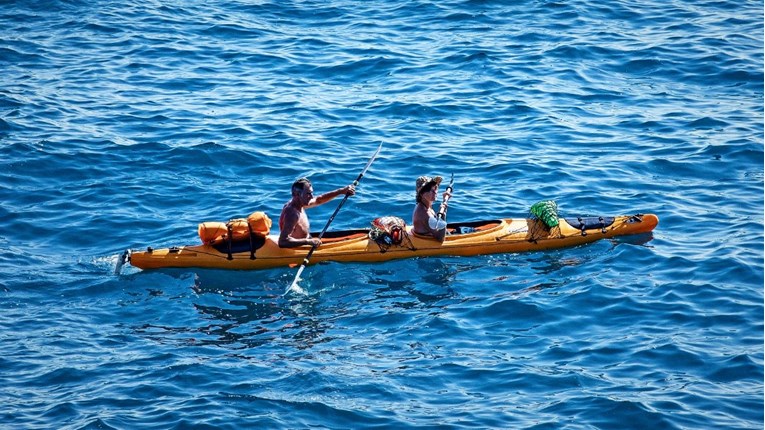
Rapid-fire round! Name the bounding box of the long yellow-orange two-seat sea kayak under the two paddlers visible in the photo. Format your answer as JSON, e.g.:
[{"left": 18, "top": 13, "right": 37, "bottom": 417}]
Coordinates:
[{"left": 118, "top": 214, "right": 659, "bottom": 270}]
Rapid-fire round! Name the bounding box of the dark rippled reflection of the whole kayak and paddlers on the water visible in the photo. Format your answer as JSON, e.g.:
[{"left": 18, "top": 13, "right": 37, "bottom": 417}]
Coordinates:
[{"left": 127, "top": 235, "right": 651, "bottom": 349}]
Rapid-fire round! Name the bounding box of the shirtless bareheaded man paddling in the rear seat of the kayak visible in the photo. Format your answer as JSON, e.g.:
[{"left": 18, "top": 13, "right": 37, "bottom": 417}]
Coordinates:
[{"left": 279, "top": 178, "right": 356, "bottom": 248}]
